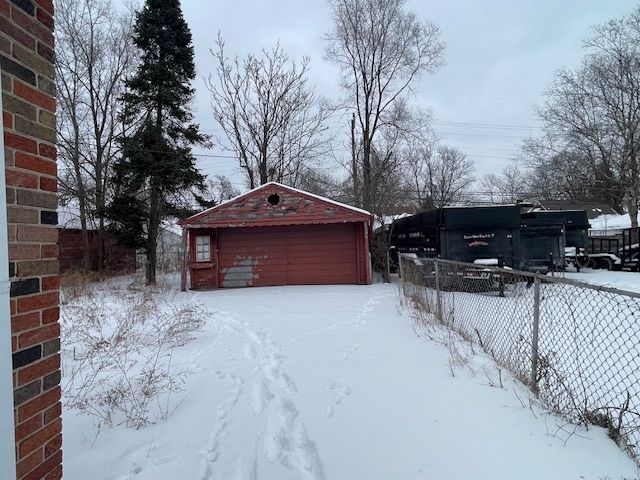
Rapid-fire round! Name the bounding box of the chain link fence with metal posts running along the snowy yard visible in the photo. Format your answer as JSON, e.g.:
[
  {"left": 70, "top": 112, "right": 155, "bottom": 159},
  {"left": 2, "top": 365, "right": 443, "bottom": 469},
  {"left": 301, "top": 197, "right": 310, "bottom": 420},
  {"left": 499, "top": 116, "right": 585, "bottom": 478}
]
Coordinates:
[{"left": 400, "top": 255, "right": 640, "bottom": 461}]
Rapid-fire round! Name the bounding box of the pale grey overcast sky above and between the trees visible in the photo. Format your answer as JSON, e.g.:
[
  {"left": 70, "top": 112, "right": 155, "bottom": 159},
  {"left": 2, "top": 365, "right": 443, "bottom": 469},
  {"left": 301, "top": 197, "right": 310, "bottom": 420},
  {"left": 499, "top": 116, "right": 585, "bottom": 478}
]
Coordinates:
[{"left": 169, "top": 0, "right": 637, "bottom": 186}]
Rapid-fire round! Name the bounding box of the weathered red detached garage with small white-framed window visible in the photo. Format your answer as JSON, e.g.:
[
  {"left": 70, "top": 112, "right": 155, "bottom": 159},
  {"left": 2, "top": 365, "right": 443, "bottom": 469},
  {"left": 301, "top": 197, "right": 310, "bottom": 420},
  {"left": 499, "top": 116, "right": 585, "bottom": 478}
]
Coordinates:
[{"left": 180, "top": 182, "right": 373, "bottom": 289}]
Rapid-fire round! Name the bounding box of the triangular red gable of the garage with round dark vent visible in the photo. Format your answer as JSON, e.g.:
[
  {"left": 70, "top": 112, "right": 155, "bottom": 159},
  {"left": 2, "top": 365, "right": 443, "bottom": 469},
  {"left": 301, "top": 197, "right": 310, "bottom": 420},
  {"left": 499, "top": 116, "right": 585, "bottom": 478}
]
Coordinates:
[{"left": 180, "top": 182, "right": 372, "bottom": 228}]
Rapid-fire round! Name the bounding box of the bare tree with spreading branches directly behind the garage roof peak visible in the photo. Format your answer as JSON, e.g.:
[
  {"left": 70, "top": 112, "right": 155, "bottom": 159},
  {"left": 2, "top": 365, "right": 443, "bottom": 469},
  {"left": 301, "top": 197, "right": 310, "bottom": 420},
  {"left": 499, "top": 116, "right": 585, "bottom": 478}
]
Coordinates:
[{"left": 207, "top": 35, "right": 333, "bottom": 188}]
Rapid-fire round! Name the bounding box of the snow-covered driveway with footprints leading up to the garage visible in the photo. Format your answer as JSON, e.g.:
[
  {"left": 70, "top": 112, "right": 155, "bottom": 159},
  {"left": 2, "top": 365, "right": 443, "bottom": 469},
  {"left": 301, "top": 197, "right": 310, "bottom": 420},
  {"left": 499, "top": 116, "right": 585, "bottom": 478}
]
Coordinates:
[{"left": 63, "top": 274, "right": 640, "bottom": 480}]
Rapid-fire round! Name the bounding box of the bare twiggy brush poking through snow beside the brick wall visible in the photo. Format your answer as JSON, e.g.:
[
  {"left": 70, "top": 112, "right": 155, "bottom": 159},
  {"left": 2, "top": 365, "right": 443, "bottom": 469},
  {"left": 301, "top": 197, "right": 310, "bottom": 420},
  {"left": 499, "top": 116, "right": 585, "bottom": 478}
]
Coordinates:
[{"left": 61, "top": 279, "right": 206, "bottom": 430}]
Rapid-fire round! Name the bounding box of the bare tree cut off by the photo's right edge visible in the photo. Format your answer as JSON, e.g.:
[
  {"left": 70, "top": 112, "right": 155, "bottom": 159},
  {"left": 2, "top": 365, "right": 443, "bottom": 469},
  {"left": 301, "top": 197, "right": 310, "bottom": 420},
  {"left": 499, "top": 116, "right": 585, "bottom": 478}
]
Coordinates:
[{"left": 539, "top": 8, "right": 640, "bottom": 226}]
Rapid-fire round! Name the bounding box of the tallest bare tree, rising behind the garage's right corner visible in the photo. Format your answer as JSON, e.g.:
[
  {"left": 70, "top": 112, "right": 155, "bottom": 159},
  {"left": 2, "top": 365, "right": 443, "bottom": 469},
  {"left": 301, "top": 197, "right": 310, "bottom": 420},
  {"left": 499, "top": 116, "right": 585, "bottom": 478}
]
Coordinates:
[{"left": 326, "top": 0, "right": 444, "bottom": 209}]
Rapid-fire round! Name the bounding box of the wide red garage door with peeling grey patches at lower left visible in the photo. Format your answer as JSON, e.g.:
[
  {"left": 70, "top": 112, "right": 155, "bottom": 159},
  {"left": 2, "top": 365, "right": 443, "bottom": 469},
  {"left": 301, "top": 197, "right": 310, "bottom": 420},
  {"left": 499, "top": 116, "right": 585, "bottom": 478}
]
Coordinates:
[{"left": 218, "top": 223, "right": 358, "bottom": 287}]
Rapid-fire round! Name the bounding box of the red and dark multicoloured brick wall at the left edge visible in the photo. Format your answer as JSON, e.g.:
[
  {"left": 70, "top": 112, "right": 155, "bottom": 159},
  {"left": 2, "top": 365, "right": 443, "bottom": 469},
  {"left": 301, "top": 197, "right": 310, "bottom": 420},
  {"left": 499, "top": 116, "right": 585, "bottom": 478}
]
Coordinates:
[{"left": 0, "top": 0, "right": 62, "bottom": 480}]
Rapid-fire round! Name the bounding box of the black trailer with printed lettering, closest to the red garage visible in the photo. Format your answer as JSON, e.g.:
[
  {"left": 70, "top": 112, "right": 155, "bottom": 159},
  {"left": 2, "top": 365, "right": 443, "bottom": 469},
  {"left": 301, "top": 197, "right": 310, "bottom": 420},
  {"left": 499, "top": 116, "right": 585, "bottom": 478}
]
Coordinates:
[{"left": 391, "top": 205, "right": 523, "bottom": 269}]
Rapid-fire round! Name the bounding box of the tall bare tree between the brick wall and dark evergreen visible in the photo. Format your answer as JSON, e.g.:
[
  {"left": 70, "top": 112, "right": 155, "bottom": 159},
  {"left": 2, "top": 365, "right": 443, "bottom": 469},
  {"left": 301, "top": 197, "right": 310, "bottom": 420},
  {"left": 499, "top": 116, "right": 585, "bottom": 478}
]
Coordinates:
[{"left": 56, "top": 0, "right": 135, "bottom": 271}]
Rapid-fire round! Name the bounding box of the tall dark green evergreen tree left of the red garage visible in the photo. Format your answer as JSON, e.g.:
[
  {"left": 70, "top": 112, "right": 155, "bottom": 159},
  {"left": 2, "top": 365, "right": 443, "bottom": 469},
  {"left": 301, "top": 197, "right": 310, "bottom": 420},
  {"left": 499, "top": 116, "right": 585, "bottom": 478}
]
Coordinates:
[{"left": 109, "top": 0, "right": 208, "bottom": 285}]
